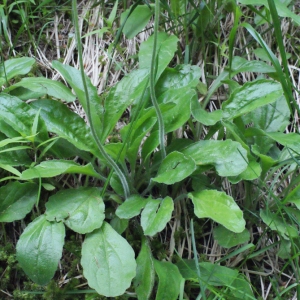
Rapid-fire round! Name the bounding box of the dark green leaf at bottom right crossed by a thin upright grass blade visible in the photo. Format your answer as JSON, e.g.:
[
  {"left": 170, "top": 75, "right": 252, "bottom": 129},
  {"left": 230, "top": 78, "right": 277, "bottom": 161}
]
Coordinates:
[{"left": 176, "top": 259, "right": 238, "bottom": 286}]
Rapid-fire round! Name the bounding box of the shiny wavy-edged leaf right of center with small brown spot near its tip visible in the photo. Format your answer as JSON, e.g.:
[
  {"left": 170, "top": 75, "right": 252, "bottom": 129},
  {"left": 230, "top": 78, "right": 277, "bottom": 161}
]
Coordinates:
[{"left": 182, "top": 140, "right": 248, "bottom": 176}]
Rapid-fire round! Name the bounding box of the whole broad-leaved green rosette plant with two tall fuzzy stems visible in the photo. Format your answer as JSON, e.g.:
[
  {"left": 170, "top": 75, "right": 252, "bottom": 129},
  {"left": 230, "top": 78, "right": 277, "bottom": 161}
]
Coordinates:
[{"left": 0, "top": 1, "right": 300, "bottom": 299}]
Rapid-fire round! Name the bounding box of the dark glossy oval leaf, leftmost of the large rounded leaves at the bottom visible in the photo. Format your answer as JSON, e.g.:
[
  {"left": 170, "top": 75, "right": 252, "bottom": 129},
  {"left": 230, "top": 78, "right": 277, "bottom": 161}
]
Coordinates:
[{"left": 17, "top": 215, "right": 65, "bottom": 285}]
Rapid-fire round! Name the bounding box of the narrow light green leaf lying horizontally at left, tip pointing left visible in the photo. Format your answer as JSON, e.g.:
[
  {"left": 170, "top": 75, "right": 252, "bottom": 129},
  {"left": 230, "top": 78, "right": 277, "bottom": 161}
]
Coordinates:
[{"left": 21, "top": 160, "right": 100, "bottom": 180}]
